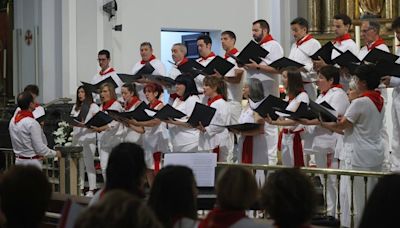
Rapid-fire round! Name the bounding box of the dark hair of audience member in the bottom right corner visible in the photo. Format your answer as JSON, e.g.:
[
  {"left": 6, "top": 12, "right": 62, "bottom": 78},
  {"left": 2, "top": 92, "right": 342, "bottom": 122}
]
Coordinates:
[{"left": 359, "top": 174, "right": 400, "bottom": 228}]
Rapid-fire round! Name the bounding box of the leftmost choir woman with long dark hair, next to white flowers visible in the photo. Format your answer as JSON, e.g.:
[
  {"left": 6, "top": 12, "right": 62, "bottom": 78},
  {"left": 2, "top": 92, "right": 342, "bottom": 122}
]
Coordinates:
[{"left": 71, "top": 86, "right": 99, "bottom": 196}]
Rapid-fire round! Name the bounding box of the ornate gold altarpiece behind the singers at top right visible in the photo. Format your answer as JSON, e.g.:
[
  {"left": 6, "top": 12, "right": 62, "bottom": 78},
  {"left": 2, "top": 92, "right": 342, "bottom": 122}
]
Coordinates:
[{"left": 307, "top": 0, "right": 399, "bottom": 48}]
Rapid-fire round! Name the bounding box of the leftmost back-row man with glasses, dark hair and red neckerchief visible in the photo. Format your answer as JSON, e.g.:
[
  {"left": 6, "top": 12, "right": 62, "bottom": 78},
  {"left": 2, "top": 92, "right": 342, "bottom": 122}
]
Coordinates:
[{"left": 92, "top": 50, "right": 124, "bottom": 104}]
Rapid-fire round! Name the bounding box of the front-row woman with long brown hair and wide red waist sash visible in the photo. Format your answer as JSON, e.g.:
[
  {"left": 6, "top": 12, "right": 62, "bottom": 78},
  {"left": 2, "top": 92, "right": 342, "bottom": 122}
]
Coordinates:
[{"left": 265, "top": 71, "right": 310, "bottom": 167}]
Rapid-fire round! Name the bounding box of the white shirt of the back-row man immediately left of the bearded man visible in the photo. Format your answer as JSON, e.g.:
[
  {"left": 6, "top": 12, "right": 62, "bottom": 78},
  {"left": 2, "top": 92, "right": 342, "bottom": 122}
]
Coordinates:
[{"left": 225, "top": 52, "right": 246, "bottom": 102}]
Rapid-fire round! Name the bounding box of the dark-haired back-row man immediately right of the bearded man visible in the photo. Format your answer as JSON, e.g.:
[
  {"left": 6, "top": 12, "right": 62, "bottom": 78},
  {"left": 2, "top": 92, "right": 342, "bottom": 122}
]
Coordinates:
[{"left": 289, "top": 17, "right": 321, "bottom": 100}]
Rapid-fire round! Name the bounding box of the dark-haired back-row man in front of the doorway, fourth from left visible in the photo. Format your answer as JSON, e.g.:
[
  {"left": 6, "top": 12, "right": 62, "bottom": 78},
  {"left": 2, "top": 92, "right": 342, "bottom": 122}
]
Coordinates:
[{"left": 194, "top": 35, "right": 216, "bottom": 93}]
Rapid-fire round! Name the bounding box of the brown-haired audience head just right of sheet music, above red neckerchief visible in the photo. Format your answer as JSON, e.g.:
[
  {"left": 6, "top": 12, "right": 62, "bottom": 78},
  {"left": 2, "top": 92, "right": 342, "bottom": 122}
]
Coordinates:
[{"left": 216, "top": 167, "right": 259, "bottom": 210}]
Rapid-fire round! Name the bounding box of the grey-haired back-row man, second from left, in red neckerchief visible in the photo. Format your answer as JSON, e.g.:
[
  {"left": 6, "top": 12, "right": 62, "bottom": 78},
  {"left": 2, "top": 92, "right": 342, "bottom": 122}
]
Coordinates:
[{"left": 131, "top": 42, "right": 166, "bottom": 102}]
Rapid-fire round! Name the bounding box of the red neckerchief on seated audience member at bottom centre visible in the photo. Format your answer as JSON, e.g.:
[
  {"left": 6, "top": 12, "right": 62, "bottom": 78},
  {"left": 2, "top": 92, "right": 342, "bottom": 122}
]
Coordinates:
[{"left": 199, "top": 208, "right": 246, "bottom": 228}]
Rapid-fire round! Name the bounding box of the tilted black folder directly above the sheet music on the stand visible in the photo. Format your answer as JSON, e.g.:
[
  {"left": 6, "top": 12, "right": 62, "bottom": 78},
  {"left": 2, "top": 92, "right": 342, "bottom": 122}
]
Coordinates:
[{"left": 187, "top": 102, "right": 217, "bottom": 127}]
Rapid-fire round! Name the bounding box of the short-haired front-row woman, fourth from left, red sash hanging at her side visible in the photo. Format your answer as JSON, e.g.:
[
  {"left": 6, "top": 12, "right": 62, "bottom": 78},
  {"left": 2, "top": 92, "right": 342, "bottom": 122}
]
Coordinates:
[{"left": 130, "top": 83, "right": 169, "bottom": 186}]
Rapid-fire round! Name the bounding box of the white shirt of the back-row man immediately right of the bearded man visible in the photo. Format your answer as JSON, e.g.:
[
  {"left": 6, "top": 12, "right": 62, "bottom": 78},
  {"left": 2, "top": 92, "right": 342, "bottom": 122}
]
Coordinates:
[{"left": 289, "top": 35, "right": 321, "bottom": 100}]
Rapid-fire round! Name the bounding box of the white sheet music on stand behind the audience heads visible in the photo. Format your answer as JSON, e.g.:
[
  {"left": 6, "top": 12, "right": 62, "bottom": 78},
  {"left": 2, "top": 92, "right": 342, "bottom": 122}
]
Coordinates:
[{"left": 164, "top": 152, "right": 217, "bottom": 187}]
